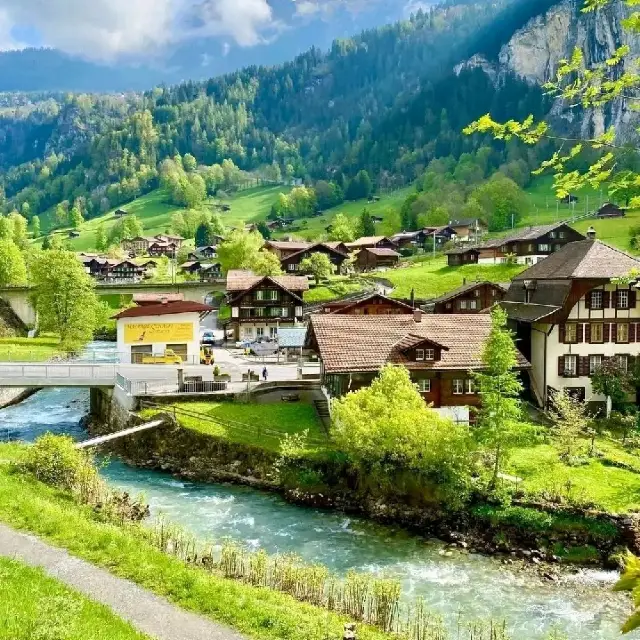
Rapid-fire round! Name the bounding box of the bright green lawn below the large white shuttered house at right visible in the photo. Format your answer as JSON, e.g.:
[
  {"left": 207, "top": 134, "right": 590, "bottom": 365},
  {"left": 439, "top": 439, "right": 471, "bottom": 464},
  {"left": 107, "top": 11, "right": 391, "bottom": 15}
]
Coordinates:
[{"left": 509, "top": 439, "right": 640, "bottom": 512}]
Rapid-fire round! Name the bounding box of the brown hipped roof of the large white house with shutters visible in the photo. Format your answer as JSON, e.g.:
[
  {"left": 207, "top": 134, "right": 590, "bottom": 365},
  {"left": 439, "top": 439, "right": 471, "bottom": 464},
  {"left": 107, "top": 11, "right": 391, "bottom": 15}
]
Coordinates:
[{"left": 514, "top": 239, "right": 640, "bottom": 280}]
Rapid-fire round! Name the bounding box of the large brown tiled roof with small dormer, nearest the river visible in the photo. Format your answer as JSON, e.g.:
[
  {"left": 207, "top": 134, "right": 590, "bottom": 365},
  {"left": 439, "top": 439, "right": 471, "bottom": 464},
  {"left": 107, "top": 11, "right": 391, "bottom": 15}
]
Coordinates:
[{"left": 309, "top": 314, "right": 529, "bottom": 373}]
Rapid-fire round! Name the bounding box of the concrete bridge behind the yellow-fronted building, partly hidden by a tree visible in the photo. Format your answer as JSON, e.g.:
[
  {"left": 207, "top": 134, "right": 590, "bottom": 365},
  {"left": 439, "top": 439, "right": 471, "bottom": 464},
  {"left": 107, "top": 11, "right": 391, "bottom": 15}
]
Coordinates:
[{"left": 0, "top": 280, "right": 226, "bottom": 326}]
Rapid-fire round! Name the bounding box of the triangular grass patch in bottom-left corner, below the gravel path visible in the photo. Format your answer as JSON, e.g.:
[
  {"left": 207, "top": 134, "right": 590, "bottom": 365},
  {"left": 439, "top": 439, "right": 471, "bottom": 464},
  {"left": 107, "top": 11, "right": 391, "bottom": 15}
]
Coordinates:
[{"left": 0, "top": 558, "right": 148, "bottom": 640}]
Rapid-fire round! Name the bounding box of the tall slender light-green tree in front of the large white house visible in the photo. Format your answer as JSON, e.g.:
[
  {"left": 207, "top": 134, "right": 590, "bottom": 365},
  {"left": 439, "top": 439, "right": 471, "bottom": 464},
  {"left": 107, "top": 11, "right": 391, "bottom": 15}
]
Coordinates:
[{"left": 475, "top": 307, "right": 522, "bottom": 488}]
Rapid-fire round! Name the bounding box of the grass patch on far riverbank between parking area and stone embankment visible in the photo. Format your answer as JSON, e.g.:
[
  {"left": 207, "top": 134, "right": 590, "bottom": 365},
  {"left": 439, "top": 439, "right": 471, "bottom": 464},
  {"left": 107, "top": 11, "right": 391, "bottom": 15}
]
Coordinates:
[{"left": 150, "top": 402, "right": 327, "bottom": 453}]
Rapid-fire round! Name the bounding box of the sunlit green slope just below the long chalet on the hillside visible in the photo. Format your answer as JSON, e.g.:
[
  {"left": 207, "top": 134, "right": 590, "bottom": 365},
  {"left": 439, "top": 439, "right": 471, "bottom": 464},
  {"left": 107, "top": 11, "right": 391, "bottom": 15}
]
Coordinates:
[{"left": 380, "top": 257, "right": 525, "bottom": 299}]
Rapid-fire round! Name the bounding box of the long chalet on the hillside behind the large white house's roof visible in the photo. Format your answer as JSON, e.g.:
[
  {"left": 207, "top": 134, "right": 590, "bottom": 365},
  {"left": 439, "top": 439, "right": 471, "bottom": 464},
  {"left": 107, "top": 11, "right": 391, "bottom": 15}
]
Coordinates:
[{"left": 449, "top": 222, "right": 584, "bottom": 265}]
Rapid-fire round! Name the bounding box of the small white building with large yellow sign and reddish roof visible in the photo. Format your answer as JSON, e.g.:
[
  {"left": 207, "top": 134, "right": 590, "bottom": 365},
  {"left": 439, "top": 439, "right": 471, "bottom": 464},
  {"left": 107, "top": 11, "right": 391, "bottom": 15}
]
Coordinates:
[{"left": 114, "top": 300, "right": 213, "bottom": 364}]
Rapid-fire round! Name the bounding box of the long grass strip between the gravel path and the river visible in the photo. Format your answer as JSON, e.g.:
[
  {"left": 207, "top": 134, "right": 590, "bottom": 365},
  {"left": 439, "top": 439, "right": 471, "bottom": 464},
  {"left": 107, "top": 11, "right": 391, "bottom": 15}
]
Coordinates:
[{"left": 0, "top": 444, "right": 400, "bottom": 640}]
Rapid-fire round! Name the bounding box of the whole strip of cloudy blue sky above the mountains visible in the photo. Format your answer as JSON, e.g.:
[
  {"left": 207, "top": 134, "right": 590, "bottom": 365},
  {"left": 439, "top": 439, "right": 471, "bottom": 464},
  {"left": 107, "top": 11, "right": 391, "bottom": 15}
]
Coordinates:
[{"left": 0, "top": 0, "right": 430, "bottom": 63}]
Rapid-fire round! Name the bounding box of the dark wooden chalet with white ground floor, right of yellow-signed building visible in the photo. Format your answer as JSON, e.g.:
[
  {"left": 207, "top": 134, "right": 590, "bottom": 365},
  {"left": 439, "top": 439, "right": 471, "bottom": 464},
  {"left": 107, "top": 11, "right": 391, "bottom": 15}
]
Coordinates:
[{"left": 227, "top": 269, "right": 309, "bottom": 340}]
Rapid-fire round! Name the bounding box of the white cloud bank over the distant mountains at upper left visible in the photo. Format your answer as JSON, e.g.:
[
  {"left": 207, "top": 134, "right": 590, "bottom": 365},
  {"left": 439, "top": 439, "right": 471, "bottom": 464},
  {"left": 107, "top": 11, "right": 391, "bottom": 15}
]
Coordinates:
[{"left": 0, "top": 0, "right": 278, "bottom": 61}]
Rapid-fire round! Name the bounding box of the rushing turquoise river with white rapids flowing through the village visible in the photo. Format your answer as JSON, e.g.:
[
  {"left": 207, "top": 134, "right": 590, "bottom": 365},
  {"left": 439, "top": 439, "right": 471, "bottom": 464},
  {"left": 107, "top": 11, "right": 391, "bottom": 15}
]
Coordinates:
[{"left": 0, "top": 368, "right": 629, "bottom": 640}]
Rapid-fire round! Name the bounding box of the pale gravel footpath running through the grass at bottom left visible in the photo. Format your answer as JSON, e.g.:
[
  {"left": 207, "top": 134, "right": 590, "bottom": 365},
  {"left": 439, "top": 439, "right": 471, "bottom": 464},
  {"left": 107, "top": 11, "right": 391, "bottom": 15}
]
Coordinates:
[{"left": 0, "top": 524, "right": 244, "bottom": 640}]
